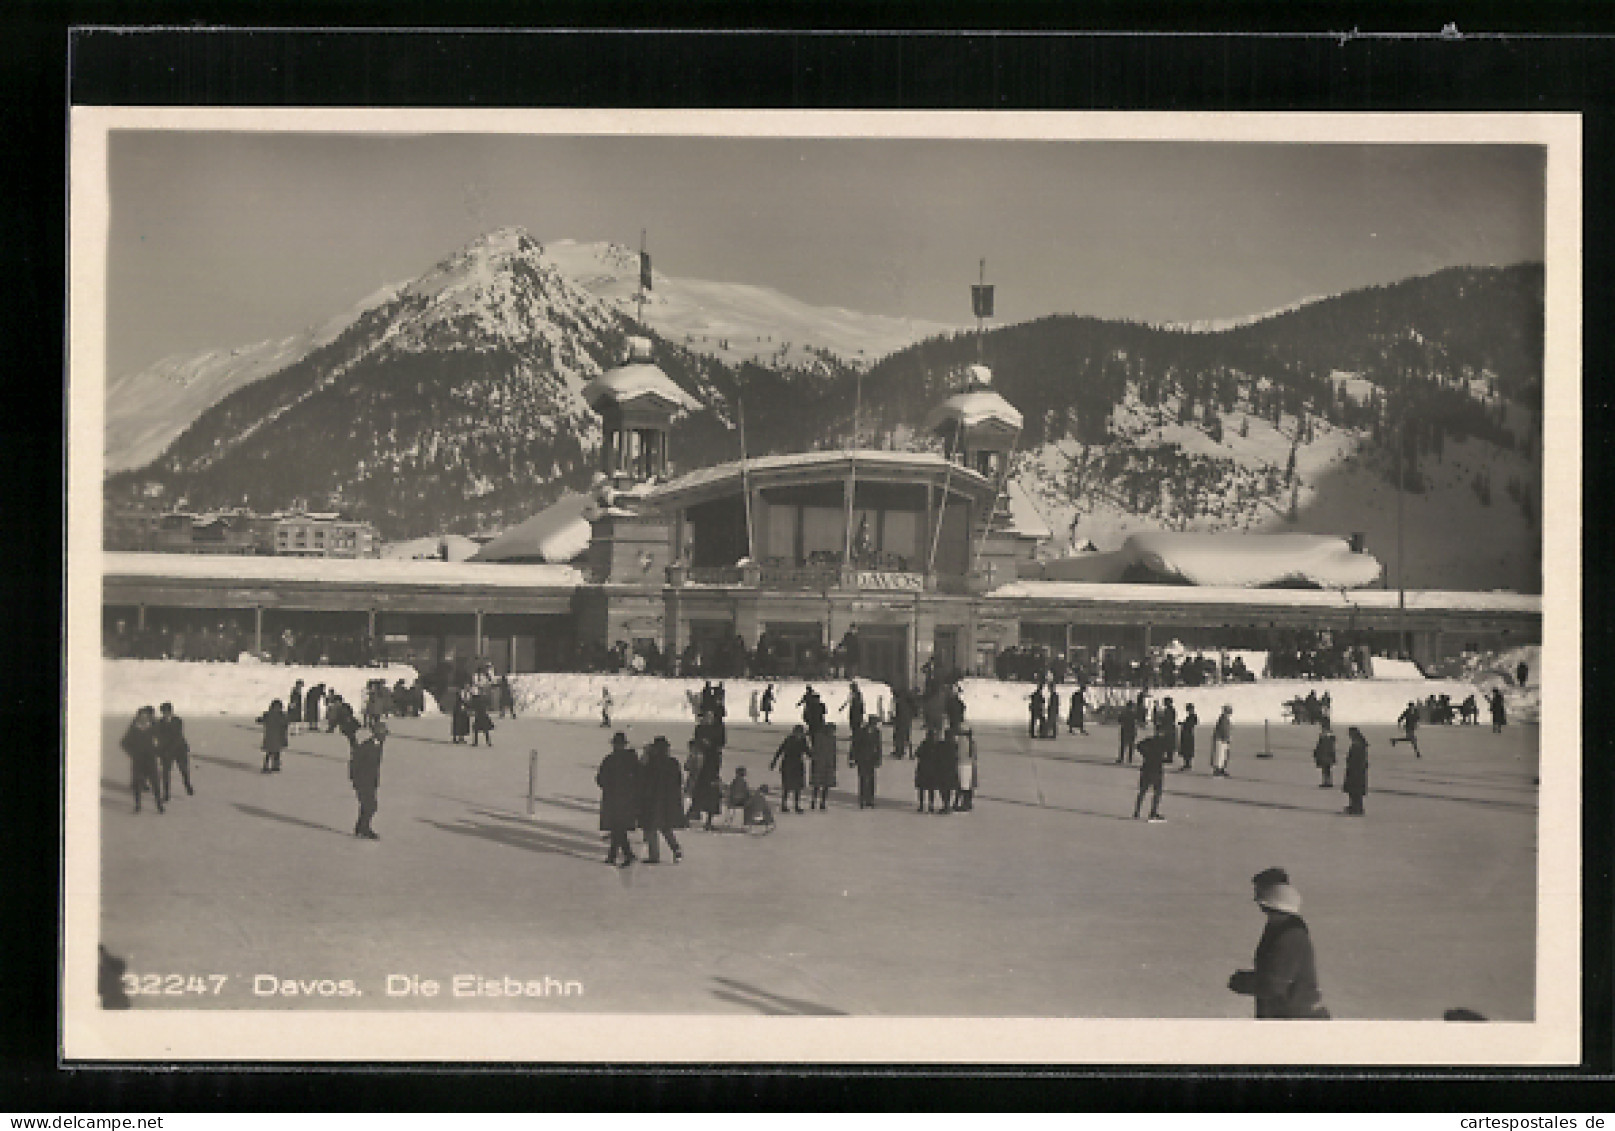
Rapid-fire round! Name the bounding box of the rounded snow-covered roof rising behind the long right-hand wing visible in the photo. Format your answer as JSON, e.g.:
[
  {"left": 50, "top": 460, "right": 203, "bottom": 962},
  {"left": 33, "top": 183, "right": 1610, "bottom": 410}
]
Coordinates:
[{"left": 1043, "top": 532, "right": 1381, "bottom": 590}]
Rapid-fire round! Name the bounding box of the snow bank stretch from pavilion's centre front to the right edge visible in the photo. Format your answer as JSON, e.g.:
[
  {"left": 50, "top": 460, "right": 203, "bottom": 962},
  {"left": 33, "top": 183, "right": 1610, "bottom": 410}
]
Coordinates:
[{"left": 510, "top": 674, "right": 1511, "bottom": 737}]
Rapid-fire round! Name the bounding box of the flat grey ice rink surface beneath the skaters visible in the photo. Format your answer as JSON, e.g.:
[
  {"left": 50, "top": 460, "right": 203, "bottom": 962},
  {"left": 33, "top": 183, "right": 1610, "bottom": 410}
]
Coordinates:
[{"left": 97, "top": 717, "right": 1537, "bottom": 1021}]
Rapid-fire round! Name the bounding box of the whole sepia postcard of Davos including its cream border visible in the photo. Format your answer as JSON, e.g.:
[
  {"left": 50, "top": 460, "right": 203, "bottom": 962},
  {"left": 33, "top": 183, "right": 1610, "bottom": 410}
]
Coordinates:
[{"left": 63, "top": 107, "right": 1581, "bottom": 1065}]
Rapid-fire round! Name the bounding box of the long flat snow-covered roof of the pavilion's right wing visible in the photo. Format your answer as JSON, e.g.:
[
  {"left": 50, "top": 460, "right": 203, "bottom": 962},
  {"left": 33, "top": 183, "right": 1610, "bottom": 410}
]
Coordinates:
[{"left": 990, "top": 580, "right": 1542, "bottom": 616}]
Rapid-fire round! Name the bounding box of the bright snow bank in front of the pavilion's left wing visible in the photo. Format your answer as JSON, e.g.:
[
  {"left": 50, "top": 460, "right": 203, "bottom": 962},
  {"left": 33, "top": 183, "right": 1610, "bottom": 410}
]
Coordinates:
[{"left": 102, "top": 659, "right": 438, "bottom": 716}]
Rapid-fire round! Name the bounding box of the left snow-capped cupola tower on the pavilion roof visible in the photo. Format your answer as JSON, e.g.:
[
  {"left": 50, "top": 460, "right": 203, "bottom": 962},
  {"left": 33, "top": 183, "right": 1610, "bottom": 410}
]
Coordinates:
[{"left": 583, "top": 338, "right": 701, "bottom": 485}]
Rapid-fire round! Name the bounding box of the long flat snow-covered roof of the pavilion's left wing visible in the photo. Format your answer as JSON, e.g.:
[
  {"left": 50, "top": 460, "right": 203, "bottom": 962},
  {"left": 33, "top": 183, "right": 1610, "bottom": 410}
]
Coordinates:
[{"left": 102, "top": 553, "right": 588, "bottom": 588}]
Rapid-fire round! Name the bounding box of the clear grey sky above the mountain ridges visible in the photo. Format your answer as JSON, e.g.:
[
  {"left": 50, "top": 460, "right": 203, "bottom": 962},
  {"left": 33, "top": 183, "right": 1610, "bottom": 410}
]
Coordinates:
[{"left": 107, "top": 131, "right": 1544, "bottom": 375}]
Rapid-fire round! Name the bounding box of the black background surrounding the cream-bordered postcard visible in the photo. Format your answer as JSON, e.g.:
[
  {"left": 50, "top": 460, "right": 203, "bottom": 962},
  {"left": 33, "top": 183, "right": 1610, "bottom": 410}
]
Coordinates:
[{"left": 0, "top": 0, "right": 1615, "bottom": 1118}]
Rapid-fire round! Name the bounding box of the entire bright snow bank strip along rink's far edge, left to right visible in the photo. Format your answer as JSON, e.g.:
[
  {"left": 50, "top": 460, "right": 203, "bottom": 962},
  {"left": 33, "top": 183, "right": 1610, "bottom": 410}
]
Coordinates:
[{"left": 102, "top": 659, "right": 1541, "bottom": 725}]
